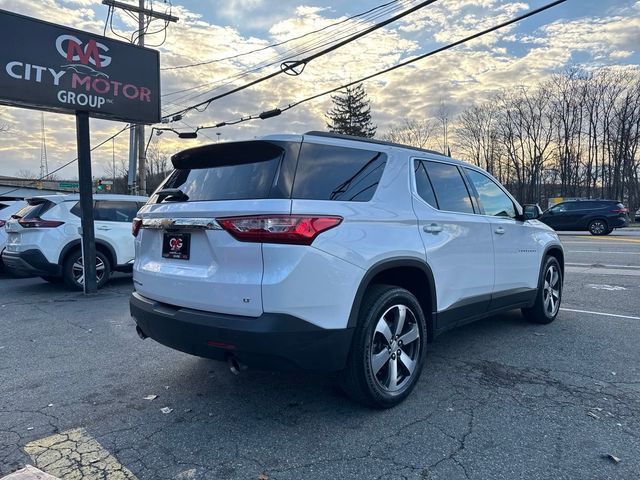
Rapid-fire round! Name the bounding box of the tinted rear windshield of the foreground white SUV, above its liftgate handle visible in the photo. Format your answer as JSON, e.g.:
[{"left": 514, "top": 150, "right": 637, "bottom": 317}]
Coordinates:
[{"left": 158, "top": 142, "right": 288, "bottom": 203}]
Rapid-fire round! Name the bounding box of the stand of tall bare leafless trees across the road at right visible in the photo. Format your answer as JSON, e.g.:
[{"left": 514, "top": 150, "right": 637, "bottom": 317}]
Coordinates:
[{"left": 450, "top": 67, "right": 640, "bottom": 209}]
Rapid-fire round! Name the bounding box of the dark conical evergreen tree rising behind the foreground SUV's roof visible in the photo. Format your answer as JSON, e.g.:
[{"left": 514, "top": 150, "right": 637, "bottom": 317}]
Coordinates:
[{"left": 327, "top": 83, "right": 377, "bottom": 138}]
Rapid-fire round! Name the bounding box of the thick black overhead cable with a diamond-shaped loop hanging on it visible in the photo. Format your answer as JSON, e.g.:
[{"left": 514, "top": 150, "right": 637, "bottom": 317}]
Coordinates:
[{"left": 164, "top": 0, "right": 438, "bottom": 119}]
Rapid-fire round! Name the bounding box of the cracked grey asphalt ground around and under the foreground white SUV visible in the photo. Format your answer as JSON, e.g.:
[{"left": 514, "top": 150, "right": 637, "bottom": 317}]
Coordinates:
[{"left": 0, "top": 230, "right": 640, "bottom": 480}]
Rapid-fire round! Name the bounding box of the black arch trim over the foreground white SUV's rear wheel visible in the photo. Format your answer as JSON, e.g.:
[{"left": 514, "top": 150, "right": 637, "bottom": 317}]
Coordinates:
[{"left": 347, "top": 257, "right": 437, "bottom": 341}]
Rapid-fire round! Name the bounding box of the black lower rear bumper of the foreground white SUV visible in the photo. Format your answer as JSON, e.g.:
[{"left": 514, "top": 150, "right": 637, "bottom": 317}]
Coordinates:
[{"left": 129, "top": 292, "right": 353, "bottom": 372}]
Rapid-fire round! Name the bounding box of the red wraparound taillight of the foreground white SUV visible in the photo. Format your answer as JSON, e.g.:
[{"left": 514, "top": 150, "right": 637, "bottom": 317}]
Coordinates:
[{"left": 216, "top": 215, "right": 342, "bottom": 245}]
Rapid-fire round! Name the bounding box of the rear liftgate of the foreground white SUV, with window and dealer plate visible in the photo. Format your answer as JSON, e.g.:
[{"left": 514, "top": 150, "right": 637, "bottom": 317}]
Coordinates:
[{"left": 134, "top": 141, "right": 300, "bottom": 317}]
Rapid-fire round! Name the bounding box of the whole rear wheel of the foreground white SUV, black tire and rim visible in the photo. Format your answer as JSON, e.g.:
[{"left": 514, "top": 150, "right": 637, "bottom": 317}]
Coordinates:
[{"left": 340, "top": 285, "right": 427, "bottom": 408}]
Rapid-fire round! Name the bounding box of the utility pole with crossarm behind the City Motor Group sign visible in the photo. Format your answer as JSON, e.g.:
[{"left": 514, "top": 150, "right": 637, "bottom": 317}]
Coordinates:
[{"left": 102, "top": 0, "right": 179, "bottom": 195}]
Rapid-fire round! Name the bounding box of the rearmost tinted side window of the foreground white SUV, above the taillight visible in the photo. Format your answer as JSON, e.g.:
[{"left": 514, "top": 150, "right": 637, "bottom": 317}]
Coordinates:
[{"left": 292, "top": 143, "right": 387, "bottom": 202}]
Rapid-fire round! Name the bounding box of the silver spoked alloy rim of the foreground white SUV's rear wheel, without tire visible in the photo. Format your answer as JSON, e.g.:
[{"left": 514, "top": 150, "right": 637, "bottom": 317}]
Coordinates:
[{"left": 370, "top": 304, "right": 420, "bottom": 393}]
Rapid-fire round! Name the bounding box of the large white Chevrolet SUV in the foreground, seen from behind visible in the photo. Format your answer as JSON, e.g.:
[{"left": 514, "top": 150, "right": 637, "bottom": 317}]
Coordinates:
[{"left": 130, "top": 132, "right": 564, "bottom": 407}]
